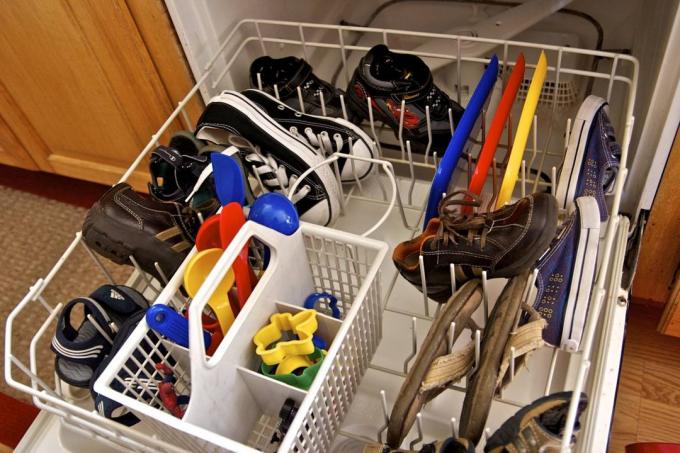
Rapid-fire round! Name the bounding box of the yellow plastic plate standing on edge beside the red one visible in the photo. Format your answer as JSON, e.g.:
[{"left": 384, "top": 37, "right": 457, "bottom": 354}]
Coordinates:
[{"left": 496, "top": 51, "right": 548, "bottom": 209}]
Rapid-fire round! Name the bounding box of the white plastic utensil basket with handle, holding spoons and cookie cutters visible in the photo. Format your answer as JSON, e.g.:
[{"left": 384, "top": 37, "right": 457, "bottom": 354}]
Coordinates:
[{"left": 95, "top": 222, "right": 387, "bottom": 451}]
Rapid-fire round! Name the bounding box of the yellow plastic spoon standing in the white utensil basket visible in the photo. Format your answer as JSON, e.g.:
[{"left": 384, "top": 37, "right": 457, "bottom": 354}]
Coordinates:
[{"left": 184, "top": 248, "right": 234, "bottom": 334}]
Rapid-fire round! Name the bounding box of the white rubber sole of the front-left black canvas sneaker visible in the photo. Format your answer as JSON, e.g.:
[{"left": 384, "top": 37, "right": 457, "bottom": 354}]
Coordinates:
[{"left": 203, "top": 91, "right": 340, "bottom": 225}]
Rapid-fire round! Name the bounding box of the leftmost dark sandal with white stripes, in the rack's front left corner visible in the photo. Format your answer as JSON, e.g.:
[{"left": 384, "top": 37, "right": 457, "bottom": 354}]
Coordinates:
[{"left": 50, "top": 285, "right": 148, "bottom": 388}]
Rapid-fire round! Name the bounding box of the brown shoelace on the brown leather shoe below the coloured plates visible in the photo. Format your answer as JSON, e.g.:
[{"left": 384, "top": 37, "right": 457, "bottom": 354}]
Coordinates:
[{"left": 437, "top": 190, "right": 493, "bottom": 249}]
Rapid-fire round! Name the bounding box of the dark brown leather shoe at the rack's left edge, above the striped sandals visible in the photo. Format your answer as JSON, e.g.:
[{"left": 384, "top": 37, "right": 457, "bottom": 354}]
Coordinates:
[{"left": 83, "top": 183, "right": 199, "bottom": 282}]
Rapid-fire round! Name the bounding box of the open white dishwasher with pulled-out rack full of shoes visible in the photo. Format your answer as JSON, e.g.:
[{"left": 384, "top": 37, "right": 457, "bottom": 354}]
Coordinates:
[{"left": 5, "top": 0, "right": 680, "bottom": 452}]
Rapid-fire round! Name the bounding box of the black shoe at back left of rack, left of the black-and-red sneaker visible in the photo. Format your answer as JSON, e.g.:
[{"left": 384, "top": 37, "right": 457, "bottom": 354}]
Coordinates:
[{"left": 250, "top": 56, "right": 344, "bottom": 118}]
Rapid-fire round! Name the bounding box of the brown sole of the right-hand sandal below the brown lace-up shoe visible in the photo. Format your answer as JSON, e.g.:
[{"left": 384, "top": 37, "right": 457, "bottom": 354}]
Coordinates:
[{"left": 460, "top": 272, "right": 529, "bottom": 444}]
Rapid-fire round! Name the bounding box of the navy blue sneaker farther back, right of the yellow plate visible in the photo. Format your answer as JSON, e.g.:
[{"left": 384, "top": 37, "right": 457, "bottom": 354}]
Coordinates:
[{"left": 556, "top": 95, "right": 621, "bottom": 222}]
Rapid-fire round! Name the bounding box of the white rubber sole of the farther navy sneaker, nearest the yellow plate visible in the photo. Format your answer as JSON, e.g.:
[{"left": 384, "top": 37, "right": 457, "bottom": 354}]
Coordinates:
[{"left": 555, "top": 95, "right": 607, "bottom": 209}]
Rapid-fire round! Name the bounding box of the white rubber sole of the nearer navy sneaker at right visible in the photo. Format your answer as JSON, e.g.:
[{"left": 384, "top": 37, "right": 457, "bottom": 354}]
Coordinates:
[{"left": 561, "top": 197, "right": 600, "bottom": 352}]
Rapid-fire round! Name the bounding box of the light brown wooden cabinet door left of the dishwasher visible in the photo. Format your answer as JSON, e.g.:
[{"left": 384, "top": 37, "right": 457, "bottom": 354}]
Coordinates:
[{"left": 0, "top": 0, "right": 201, "bottom": 187}]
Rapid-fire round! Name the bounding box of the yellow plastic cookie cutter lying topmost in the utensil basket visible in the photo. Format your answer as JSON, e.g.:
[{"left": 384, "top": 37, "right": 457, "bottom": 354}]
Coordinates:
[{"left": 253, "top": 310, "right": 318, "bottom": 365}]
